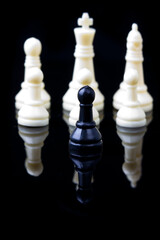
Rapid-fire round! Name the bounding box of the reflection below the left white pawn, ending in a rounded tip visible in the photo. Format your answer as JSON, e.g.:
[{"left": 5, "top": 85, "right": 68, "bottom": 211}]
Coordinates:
[{"left": 18, "top": 125, "right": 48, "bottom": 177}]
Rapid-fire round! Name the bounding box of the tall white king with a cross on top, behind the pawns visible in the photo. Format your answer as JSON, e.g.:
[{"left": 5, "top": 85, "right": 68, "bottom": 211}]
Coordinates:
[{"left": 63, "top": 13, "right": 104, "bottom": 115}]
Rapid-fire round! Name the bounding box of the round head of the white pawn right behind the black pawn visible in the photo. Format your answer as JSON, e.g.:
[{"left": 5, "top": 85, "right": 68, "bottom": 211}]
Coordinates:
[{"left": 77, "top": 68, "right": 92, "bottom": 85}]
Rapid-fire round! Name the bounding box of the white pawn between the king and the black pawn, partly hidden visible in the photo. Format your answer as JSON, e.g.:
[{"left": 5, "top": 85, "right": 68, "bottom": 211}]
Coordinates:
[{"left": 69, "top": 68, "right": 100, "bottom": 129}]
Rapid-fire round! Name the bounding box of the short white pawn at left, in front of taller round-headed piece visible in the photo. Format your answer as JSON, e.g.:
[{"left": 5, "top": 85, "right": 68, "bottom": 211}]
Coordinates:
[{"left": 18, "top": 68, "right": 49, "bottom": 127}]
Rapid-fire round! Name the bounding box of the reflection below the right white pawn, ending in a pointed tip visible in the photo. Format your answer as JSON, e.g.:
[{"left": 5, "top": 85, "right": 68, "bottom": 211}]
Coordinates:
[{"left": 117, "top": 125, "right": 146, "bottom": 188}]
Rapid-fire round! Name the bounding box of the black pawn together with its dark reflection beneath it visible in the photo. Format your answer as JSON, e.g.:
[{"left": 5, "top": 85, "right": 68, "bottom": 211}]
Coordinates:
[{"left": 69, "top": 86, "right": 103, "bottom": 204}]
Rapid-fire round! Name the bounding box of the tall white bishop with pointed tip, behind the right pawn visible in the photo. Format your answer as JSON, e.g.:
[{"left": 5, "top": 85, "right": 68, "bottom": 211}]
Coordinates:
[{"left": 113, "top": 23, "right": 153, "bottom": 112}]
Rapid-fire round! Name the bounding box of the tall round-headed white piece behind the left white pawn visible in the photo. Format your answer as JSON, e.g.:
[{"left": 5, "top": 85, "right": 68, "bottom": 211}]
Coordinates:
[{"left": 15, "top": 37, "right": 51, "bottom": 109}]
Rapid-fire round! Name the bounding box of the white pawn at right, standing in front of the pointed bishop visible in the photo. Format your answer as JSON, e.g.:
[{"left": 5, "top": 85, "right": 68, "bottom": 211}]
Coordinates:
[{"left": 116, "top": 68, "right": 146, "bottom": 128}]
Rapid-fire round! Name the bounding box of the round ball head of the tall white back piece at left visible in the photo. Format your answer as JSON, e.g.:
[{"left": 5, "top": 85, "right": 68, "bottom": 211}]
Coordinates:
[{"left": 24, "top": 37, "right": 42, "bottom": 56}]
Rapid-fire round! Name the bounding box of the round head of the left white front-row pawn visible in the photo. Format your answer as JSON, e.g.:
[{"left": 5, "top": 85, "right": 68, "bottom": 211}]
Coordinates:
[{"left": 26, "top": 67, "right": 43, "bottom": 84}]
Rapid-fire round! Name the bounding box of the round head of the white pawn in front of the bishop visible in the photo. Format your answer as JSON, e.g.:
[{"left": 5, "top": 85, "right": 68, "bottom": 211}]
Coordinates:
[{"left": 124, "top": 69, "right": 138, "bottom": 85}]
